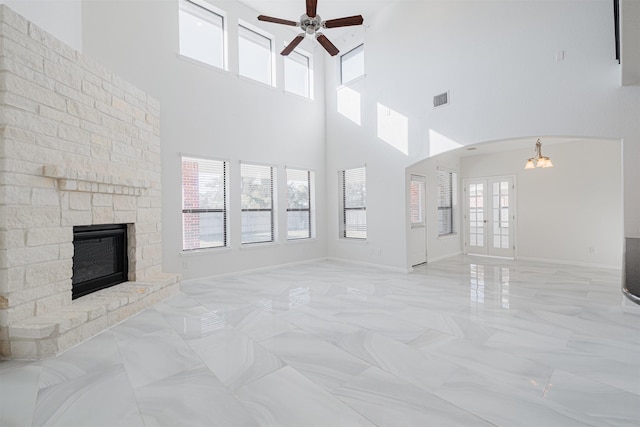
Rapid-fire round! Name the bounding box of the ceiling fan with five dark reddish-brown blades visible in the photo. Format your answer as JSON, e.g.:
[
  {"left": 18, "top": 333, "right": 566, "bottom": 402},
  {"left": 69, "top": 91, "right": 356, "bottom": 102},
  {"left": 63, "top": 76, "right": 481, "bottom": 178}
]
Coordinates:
[{"left": 258, "top": 0, "right": 364, "bottom": 56}]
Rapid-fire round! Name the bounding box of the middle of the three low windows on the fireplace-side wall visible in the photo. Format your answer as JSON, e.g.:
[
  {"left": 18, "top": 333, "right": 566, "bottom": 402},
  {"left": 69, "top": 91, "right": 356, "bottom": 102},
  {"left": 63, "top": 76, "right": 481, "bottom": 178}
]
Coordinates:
[{"left": 240, "top": 163, "right": 275, "bottom": 244}]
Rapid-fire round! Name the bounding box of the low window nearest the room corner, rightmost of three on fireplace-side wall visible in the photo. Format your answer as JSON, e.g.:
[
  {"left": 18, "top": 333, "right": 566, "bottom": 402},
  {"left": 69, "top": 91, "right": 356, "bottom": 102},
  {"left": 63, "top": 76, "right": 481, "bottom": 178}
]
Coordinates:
[{"left": 287, "top": 168, "right": 313, "bottom": 240}]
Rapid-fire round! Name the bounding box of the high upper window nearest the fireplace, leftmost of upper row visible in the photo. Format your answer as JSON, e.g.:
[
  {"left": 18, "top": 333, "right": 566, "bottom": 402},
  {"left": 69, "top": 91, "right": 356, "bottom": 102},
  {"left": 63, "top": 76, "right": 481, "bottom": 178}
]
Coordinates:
[{"left": 178, "top": 0, "right": 224, "bottom": 68}]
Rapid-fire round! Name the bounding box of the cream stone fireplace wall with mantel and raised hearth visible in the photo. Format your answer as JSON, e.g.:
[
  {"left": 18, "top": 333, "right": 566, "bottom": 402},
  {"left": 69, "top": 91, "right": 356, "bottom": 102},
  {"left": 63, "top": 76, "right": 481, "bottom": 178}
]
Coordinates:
[{"left": 0, "top": 6, "right": 179, "bottom": 358}]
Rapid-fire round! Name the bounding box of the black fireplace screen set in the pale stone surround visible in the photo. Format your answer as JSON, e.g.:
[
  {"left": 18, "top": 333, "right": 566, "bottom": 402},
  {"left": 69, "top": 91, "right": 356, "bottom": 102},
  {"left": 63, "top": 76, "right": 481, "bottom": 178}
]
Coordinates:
[{"left": 71, "top": 224, "right": 128, "bottom": 299}]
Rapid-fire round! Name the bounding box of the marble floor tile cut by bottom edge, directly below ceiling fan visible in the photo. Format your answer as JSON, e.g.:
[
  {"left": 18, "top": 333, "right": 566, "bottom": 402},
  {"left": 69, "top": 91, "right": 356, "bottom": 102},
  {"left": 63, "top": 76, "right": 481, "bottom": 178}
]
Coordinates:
[{"left": 237, "top": 367, "right": 375, "bottom": 427}]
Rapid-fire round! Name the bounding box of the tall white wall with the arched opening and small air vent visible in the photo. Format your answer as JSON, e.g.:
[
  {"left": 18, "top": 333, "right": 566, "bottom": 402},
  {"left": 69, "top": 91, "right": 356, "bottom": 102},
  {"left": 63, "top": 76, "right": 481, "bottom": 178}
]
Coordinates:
[{"left": 326, "top": 0, "right": 640, "bottom": 268}]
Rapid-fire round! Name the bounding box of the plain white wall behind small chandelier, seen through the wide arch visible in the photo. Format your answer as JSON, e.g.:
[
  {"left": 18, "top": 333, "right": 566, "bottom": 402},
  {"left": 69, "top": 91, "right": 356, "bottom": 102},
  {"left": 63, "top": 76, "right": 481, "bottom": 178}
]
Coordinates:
[{"left": 461, "top": 139, "right": 623, "bottom": 268}]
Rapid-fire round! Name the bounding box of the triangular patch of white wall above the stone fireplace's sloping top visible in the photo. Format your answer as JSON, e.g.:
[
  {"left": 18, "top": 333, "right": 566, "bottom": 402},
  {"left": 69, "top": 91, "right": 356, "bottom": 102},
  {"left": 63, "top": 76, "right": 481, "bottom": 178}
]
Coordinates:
[{"left": 0, "top": 0, "right": 82, "bottom": 52}]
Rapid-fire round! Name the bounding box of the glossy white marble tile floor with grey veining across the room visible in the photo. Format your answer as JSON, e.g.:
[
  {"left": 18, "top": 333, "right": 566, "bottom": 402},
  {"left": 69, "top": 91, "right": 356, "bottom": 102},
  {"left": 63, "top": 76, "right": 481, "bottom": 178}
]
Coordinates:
[{"left": 0, "top": 256, "right": 640, "bottom": 427}]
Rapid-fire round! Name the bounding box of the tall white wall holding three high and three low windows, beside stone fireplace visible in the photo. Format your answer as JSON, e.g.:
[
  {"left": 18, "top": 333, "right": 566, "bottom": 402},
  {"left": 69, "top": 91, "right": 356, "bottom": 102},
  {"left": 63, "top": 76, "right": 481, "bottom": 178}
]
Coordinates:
[{"left": 83, "top": 0, "right": 326, "bottom": 279}]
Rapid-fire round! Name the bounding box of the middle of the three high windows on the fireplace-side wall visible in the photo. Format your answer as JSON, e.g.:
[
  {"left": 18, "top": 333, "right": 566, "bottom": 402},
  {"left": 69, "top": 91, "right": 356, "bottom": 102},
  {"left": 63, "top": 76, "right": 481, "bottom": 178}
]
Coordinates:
[{"left": 238, "top": 25, "right": 273, "bottom": 85}]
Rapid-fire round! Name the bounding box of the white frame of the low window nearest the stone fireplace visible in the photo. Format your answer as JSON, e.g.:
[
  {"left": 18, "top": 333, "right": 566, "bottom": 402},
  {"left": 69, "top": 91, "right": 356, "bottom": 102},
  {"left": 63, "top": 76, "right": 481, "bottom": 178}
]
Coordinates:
[{"left": 180, "top": 154, "right": 230, "bottom": 253}]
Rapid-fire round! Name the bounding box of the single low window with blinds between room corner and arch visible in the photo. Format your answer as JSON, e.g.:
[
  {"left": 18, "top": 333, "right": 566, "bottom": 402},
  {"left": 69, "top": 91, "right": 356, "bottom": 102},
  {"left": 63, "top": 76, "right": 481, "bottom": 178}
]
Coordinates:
[{"left": 339, "top": 167, "right": 367, "bottom": 239}]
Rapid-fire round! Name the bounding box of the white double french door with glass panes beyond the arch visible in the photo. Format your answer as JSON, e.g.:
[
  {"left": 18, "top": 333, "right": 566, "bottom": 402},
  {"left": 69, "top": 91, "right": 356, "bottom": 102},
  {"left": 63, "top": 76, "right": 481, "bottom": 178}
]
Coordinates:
[{"left": 464, "top": 177, "right": 516, "bottom": 258}]
